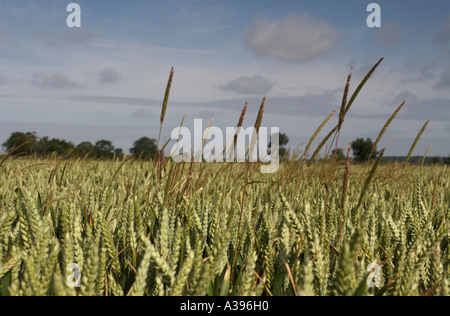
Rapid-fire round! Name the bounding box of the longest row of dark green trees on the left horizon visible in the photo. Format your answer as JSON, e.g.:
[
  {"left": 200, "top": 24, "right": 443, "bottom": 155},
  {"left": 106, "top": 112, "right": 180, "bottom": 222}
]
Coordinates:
[{"left": 2, "top": 132, "right": 158, "bottom": 159}]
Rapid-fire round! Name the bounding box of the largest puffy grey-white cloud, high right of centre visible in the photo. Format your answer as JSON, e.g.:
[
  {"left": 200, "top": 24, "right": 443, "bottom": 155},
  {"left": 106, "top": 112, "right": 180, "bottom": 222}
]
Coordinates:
[{"left": 245, "top": 14, "right": 339, "bottom": 62}]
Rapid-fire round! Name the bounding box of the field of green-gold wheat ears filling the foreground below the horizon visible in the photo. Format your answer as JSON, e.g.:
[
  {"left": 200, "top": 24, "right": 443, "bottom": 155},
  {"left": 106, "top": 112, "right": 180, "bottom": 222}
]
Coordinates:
[{"left": 0, "top": 158, "right": 450, "bottom": 296}]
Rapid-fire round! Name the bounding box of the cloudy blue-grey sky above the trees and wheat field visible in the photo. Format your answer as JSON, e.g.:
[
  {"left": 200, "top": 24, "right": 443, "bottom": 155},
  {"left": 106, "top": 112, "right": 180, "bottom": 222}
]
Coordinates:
[{"left": 0, "top": 0, "right": 450, "bottom": 156}]
